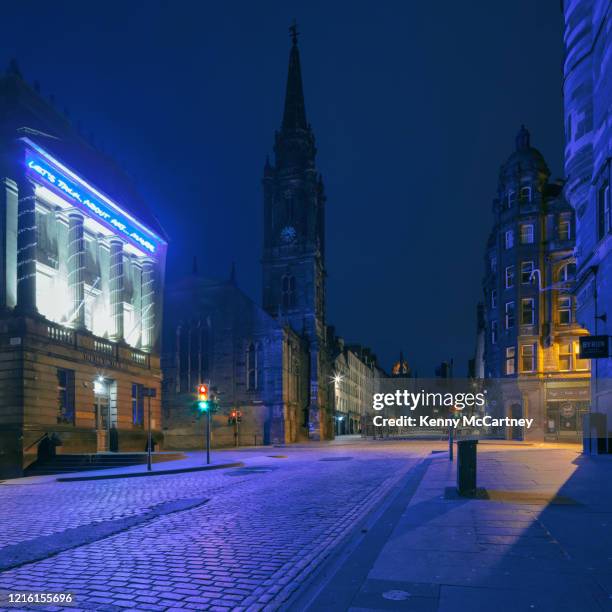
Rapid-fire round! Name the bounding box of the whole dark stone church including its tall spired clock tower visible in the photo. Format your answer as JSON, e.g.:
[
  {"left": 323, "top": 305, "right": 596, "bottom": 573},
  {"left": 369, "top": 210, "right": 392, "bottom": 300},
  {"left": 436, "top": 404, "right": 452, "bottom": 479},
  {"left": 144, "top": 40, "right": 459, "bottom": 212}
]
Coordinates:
[{"left": 163, "top": 29, "right": 334, "bottom": 448}]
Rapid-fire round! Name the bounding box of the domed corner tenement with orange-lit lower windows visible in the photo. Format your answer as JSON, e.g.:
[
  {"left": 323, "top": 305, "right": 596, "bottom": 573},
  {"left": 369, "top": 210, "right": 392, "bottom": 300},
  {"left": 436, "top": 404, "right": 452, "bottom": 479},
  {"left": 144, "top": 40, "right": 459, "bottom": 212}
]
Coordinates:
[{"left": 483, "top": 127, "right": 590, "bottom": 439}]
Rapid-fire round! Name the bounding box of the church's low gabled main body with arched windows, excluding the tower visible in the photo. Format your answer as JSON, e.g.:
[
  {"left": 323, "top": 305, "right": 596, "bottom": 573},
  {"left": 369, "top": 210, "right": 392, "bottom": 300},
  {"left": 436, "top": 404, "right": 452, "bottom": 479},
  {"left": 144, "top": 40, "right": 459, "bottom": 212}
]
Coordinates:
[{"left": 162, "top": 275, "right": 309, "bottom": 449}]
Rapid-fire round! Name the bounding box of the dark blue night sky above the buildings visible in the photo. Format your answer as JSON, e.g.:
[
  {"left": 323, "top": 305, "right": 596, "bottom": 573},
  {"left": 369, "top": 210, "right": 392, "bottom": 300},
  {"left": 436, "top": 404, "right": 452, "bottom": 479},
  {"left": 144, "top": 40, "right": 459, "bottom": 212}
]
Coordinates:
[{"left": 0, "top": 0, "right": 563, "bottom": 376}]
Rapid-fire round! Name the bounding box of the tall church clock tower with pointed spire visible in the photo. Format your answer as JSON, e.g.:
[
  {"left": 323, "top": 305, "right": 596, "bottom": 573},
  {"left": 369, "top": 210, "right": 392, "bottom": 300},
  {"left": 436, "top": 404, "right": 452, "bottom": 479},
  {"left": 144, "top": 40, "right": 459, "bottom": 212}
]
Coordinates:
[{"left": 262, "top": 25, "right": 331, "bottom": 439}]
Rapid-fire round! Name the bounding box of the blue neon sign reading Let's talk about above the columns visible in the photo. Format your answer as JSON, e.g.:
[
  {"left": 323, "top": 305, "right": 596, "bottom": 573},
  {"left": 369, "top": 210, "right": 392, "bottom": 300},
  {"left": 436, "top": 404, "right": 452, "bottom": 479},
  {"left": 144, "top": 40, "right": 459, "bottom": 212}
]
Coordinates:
[{"left": 25, "top": 142, "right": 160, "bottom": 254}]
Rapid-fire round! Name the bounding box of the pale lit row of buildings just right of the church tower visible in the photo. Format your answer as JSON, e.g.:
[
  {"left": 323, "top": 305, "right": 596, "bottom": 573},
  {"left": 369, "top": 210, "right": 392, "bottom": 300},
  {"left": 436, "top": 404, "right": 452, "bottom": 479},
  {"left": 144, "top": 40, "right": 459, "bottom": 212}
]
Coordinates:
[{"left": 333, "top": 338, "right": 382, "bottom": 436}]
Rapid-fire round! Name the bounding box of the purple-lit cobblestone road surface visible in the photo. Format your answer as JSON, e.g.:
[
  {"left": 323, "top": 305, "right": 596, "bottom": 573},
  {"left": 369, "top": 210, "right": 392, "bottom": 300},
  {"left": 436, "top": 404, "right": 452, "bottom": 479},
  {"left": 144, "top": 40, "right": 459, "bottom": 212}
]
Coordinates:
[{"left": 0, "top": 442, "right": 431, "bottom": 610}]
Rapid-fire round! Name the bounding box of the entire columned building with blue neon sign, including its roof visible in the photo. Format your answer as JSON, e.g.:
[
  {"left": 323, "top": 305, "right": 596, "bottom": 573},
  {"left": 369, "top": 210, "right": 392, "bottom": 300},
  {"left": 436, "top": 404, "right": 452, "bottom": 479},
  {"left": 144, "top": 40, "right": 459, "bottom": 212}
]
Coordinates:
[{"left": 0, "top": 65, "right": 166, "bottom": 475}]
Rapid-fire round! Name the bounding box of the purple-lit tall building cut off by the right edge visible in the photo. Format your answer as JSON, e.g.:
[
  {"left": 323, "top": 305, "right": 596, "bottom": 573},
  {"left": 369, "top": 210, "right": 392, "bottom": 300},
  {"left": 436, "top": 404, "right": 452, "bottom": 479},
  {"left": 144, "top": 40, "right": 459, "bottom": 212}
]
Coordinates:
[{"left": 563, "top": 0, "right": 612, "bottom": 418}]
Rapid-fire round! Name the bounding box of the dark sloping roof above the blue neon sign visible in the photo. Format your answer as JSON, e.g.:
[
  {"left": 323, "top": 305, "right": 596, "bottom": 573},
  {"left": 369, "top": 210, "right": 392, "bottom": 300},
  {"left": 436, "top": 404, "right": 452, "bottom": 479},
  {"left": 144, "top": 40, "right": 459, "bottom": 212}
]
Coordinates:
[{"left": 0, "top": 65, "right": 167, "bottom": 240}]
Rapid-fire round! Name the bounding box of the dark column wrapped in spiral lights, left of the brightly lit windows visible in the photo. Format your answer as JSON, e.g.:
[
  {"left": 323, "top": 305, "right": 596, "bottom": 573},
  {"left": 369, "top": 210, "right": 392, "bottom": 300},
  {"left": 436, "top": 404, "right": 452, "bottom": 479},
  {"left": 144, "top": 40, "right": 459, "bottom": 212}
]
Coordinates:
[{"left": 17, "top": 177, "right": 37, "bottom": 312}]
